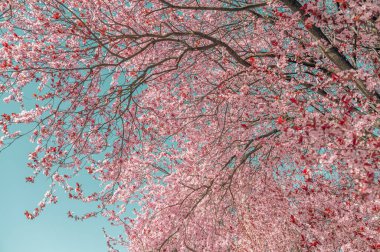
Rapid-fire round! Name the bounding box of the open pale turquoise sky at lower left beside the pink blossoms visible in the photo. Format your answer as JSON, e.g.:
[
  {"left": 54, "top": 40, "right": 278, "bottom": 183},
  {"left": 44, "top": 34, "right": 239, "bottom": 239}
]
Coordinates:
[{"left": 0, "top": 101, "right": 122, "bottom": 252}]
